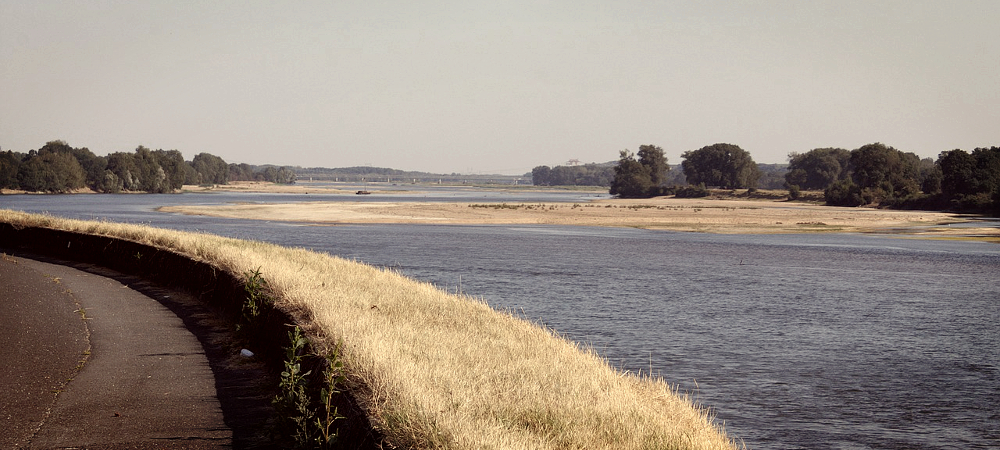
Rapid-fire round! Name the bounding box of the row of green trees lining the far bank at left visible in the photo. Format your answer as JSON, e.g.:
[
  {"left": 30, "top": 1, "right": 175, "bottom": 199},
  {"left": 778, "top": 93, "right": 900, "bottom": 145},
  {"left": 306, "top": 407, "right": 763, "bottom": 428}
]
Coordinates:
[{"left": 0, "top": 141, "right": 295, "bottom": 193}]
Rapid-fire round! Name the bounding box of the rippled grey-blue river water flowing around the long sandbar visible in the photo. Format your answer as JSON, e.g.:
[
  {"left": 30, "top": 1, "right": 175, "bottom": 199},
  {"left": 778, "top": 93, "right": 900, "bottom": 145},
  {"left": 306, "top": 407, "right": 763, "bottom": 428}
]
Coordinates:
[{"left": 0, "top": 189, "right": 1000, "bottom": 449}]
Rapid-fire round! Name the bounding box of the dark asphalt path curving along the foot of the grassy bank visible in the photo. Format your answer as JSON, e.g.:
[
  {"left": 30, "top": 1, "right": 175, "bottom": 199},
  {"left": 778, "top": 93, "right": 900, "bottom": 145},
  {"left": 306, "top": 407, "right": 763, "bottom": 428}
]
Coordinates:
[{"left": 0, "top": 255, "right": 233, "bottom": 449}]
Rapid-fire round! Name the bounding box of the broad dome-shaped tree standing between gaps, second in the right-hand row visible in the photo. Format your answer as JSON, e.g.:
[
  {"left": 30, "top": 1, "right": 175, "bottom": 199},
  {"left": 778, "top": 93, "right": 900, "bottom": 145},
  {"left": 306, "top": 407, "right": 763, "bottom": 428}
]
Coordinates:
[{"left": 681, "top": 144, "right": 760, "bottom": 189}]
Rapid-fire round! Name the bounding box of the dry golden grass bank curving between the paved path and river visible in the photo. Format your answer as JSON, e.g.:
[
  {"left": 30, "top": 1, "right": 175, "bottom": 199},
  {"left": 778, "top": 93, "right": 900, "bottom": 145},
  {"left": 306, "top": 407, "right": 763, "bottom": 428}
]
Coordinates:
[{"left": 0, "top": 210, "right": 740, "bottom": 449}]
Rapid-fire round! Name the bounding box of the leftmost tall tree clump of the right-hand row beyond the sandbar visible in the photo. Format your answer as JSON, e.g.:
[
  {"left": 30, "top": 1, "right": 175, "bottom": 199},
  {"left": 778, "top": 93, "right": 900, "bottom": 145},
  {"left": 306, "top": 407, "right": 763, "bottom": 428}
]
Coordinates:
[{"left": 609, "top": 145, "right": 670, "bottom": 198}]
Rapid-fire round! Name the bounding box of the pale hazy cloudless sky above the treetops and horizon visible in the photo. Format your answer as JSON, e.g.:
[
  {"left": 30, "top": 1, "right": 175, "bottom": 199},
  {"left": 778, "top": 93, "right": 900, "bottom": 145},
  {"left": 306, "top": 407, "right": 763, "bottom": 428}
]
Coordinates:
[{"left": 0, "top": 0, "right": 1000, "bottom": 174}]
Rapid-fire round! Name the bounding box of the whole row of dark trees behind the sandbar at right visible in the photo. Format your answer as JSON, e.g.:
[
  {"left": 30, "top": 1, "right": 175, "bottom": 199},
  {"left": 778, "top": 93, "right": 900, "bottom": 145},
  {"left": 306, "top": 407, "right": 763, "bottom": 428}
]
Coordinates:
[{"left": 609, "top": 143, "right": 1000, "bottom": 211}]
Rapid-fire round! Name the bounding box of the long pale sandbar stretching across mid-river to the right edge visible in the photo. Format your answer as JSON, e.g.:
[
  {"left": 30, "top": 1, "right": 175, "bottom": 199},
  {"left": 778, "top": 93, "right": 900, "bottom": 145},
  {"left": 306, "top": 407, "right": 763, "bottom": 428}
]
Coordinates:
[{"left": 158, "top": 198, "right": 1000, "bottom": 241}]
